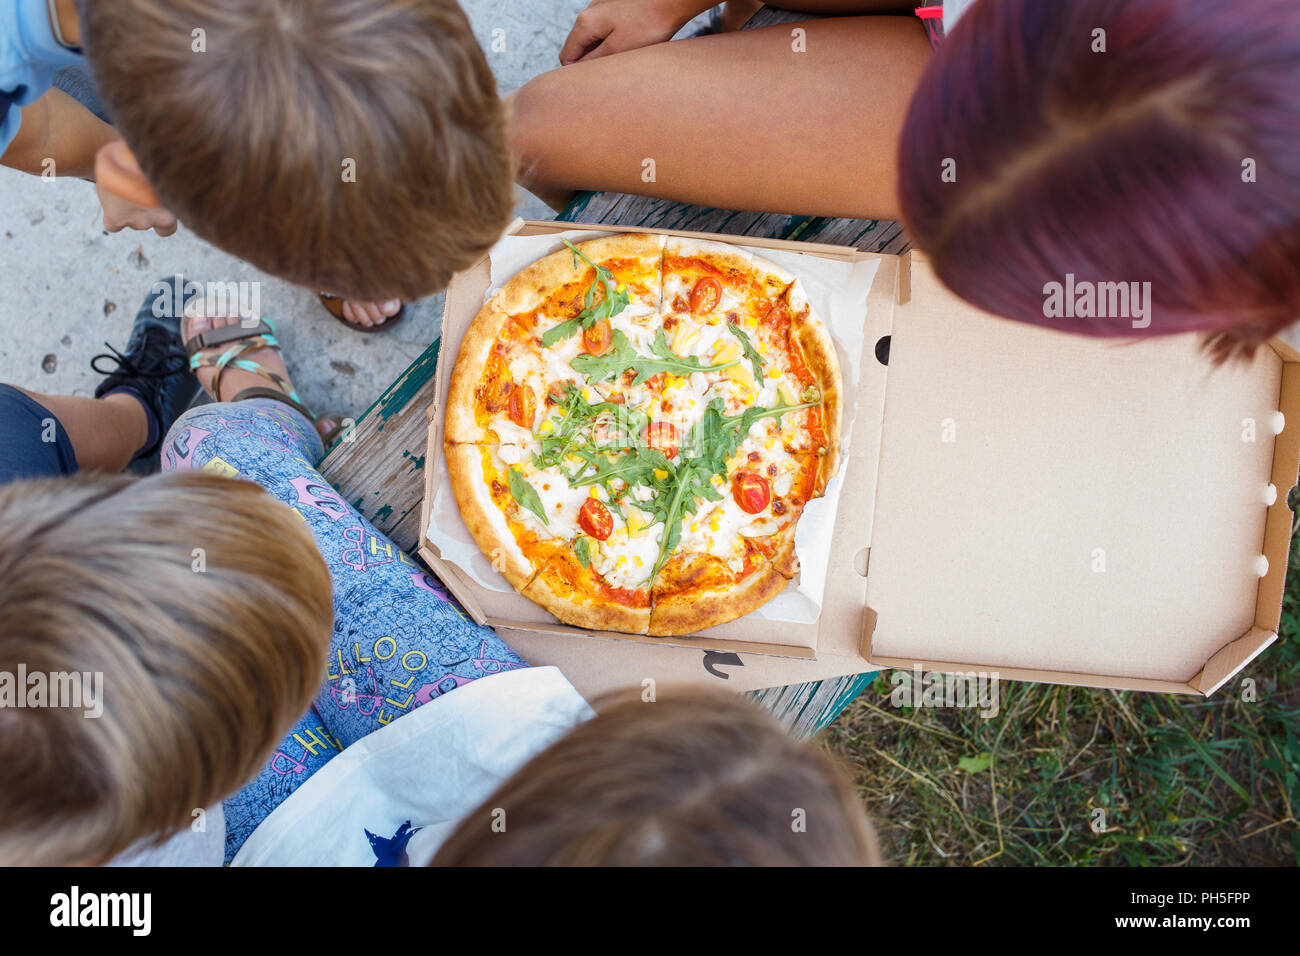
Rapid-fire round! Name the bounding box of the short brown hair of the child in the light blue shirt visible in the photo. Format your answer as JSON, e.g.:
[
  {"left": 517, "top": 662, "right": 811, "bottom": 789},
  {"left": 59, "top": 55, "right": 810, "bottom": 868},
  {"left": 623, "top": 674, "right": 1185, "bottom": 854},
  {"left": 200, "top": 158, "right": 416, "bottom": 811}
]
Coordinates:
[{"left": 79, "top": 0, "right": 515, "bottom": 300}]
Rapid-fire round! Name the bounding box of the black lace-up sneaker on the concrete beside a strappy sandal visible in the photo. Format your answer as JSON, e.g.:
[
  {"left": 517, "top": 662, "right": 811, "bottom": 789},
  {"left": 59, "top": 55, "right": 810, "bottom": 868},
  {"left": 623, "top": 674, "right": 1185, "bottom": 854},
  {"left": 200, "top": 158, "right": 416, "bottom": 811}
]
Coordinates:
[{"left": 90, "top": 280, "right": 199, "bottom": 475}]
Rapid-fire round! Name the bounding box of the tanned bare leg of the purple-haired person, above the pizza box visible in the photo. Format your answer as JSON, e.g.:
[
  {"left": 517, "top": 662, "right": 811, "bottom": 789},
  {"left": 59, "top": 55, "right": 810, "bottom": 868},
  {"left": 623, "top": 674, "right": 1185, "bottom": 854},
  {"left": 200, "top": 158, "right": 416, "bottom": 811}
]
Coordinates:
[{"left": 511, "top": 17, "right": 931, "bottom": 219}]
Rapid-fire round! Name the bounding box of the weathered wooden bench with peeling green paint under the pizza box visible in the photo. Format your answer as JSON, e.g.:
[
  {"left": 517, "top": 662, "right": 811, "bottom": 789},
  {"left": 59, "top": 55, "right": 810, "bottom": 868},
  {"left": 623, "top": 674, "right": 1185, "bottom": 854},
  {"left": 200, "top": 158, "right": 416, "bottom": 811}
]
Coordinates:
[{"left": 321, "top": 8, "right": 909, "bottom": 736}]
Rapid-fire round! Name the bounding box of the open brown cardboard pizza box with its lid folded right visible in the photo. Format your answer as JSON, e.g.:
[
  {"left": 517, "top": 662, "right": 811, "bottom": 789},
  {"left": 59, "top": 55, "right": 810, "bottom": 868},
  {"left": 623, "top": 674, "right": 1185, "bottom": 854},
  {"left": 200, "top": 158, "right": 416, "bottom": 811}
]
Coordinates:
[{"left": 420, "top": 221, "right": 1300, "bottom": 696}]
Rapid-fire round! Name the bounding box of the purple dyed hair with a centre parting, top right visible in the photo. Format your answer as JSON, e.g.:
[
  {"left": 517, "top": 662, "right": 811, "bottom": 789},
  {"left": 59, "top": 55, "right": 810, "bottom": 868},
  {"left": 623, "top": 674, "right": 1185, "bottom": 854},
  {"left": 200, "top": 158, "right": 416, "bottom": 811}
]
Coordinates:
[{"left": 898, "top": 0, "right": 1300, "bottom": 359}]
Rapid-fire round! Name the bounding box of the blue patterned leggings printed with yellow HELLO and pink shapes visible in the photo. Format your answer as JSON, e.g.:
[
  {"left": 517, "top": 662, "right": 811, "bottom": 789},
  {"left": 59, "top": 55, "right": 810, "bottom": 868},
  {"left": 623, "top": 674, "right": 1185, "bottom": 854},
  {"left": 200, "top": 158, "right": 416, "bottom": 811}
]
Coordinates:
[{"left": 163, "top": 398, "right": 528, "bottom": 862}]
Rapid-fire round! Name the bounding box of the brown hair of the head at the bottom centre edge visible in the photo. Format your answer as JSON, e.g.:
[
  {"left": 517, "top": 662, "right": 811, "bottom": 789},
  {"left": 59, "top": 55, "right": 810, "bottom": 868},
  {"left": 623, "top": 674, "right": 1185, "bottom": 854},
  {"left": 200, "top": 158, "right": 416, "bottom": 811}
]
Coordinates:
[{"left": 433, "top": 688, "right": 883, "bottom": 866}]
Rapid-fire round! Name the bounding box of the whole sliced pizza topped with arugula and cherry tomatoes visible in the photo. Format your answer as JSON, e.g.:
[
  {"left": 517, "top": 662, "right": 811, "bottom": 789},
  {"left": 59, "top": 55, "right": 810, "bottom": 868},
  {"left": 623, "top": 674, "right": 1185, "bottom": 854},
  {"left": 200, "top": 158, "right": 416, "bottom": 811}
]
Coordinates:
[{"left": 443, "top": 234, "right": 842, "bottom": 636}]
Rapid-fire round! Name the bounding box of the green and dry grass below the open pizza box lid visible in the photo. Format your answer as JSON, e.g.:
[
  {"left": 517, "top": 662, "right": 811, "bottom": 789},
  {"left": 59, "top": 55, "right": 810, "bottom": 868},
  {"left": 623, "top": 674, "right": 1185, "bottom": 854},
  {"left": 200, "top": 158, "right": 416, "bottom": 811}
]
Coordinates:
[{"left": 822, "top": 520, "right": 1300, "bottom": 866}]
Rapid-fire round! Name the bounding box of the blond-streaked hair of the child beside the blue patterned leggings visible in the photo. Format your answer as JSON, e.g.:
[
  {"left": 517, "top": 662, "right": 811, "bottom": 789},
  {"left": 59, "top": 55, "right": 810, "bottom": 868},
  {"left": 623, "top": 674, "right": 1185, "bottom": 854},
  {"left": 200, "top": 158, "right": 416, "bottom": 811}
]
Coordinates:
[{"left": 0, "top": 472, "right": 333, "bottom": 865}]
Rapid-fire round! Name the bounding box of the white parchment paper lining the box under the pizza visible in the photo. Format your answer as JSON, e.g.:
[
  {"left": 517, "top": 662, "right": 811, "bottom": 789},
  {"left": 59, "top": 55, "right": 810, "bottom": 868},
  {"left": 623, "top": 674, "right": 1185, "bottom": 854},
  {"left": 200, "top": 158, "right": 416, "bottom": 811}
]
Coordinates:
[{"left": 428, "top": 229, "right": 880, "bottom": 624}]
